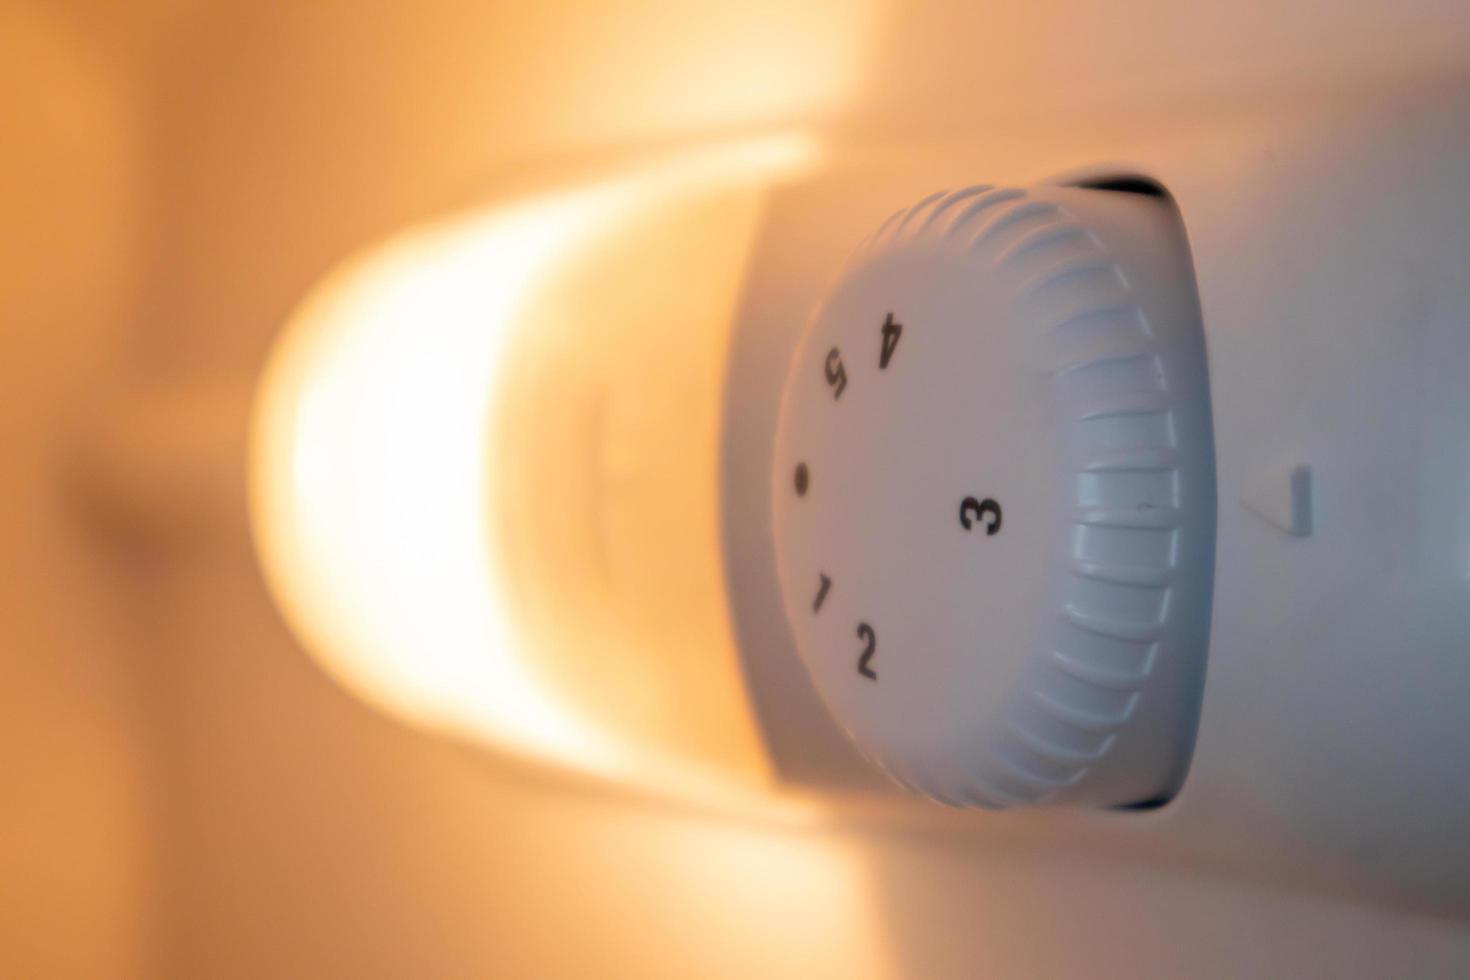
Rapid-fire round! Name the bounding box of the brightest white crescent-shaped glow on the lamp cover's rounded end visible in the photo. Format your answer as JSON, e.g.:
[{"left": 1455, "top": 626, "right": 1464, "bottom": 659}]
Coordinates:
[{"left": 251, "top": 135, "right": 816, "bottom": 811}]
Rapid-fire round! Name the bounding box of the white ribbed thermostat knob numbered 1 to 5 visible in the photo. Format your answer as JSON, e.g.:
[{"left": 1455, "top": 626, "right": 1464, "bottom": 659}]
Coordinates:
[{"left": 773, "top": 187, "right": 1216, "bottom": 808}]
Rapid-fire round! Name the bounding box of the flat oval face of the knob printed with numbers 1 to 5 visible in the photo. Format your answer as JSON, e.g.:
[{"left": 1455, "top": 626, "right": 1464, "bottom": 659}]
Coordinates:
[{"left": 773, "top": 240, "right": 1058, "bottom": 793}]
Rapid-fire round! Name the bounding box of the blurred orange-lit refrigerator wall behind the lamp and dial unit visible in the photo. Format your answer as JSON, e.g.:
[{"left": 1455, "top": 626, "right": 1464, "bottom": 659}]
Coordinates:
[{"left": 0, "top": 0, "right": 1470, "bottom": 977}]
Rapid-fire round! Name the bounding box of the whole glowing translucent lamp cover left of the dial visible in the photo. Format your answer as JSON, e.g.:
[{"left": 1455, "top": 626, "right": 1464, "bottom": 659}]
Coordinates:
[{"left": 251, "top": 135, "right": 814, "bottom": 805}]
